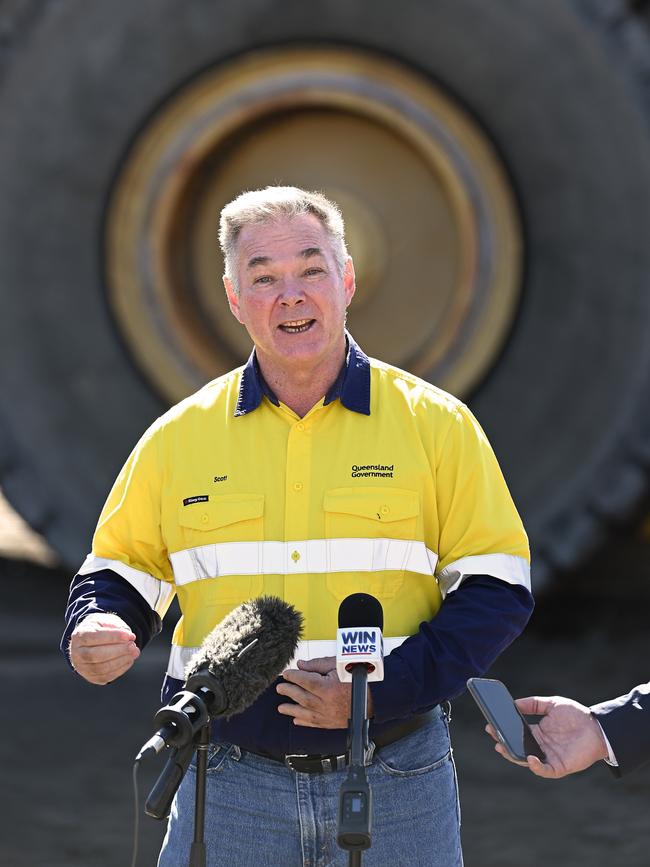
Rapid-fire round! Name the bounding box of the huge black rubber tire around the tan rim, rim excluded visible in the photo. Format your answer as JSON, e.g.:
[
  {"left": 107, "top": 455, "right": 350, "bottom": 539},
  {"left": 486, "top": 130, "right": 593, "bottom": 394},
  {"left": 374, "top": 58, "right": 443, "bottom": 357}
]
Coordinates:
[{"left": 0, "top": 0, "right": 650, "bottom": 583}]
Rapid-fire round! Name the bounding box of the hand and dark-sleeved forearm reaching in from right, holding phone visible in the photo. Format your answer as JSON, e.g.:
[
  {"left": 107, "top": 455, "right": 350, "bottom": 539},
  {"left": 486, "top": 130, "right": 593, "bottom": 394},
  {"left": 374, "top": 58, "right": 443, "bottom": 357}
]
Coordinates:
[{"left": 486, "top": 683, "right": 650, "bottom": 779}]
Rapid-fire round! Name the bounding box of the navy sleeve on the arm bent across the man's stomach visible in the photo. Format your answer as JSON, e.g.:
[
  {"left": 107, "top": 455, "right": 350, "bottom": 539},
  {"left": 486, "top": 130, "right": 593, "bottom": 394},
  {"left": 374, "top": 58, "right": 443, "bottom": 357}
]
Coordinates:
[{"left": 370, "top": 575, "right": 534, "bottom": 722}]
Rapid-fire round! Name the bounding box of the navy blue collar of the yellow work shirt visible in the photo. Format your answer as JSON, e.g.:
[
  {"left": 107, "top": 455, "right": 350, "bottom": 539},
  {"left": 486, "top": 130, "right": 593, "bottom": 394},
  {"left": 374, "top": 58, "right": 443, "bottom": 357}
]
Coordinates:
[{"left": 235, "top": 331, "right": 370, "bottom": 415}]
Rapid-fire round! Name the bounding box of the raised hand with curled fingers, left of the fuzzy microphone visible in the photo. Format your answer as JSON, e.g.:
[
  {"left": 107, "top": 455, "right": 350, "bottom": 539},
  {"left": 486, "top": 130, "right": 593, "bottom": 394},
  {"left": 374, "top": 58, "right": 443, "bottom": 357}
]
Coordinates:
[{"left": 70, "top": 614, "right": 140, "bottom": 686}]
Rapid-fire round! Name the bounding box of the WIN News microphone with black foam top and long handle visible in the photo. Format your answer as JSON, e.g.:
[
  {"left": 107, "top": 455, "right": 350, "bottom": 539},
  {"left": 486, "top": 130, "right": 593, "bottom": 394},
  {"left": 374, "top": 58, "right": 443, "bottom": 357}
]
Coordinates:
[{"left": 336, "top": 593, "right": 384, "bottom": 864}]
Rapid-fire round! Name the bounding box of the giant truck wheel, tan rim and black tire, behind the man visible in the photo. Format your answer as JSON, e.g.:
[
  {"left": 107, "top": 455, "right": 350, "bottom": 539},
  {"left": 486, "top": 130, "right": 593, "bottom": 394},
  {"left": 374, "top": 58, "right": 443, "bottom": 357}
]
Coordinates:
[{"left": 0, "top": 0, "right": 650, "bottom": 583}]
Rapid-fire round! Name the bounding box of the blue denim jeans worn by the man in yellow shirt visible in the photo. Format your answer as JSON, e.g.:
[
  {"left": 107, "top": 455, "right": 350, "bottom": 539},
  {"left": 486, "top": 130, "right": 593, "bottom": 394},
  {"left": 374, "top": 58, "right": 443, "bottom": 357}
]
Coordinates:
[{"left": 158, "top": 710, "right": 463, "bottom": 867}]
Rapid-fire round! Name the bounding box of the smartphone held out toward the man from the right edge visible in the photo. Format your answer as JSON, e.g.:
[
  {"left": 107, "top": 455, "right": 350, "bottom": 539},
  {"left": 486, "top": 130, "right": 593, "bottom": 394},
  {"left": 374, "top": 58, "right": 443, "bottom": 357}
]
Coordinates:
[{"left": 467, "top": 677, "right": 546, "bottom": 765}]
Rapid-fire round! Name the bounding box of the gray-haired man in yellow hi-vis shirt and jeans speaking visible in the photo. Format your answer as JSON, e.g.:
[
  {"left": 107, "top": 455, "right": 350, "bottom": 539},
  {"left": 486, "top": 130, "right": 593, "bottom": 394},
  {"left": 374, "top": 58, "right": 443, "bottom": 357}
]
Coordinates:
[{"left": 63, "top": 187, "right": 533, "bottom": 867}]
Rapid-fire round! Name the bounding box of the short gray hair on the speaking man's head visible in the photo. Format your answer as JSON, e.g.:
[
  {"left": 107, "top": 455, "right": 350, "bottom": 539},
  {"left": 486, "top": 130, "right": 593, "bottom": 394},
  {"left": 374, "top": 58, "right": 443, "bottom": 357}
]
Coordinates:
[{"left": 219, "top": 187, "right": 348, "bottom": 291}]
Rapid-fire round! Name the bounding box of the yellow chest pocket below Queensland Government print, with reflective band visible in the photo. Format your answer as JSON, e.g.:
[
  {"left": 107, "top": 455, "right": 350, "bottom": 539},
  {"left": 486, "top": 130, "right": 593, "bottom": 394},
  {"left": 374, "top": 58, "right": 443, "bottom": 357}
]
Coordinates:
[{"left": 323, "top": 487, "right": 420, "bottom": 600}]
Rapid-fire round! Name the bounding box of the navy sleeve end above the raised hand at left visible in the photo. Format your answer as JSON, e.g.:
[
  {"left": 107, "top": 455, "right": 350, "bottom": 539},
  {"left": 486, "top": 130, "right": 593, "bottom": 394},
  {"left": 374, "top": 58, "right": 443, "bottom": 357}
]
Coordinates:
[{"left": 61, "top": 569, "right": 162, "bottom": 665}]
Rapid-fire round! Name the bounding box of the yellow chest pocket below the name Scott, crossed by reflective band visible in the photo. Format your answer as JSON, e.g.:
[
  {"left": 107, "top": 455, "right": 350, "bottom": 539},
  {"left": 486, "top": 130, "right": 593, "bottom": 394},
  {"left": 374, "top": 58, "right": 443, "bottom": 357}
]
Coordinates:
[{"left": 172, "top": 494, "right": 264, "bottom": 605}]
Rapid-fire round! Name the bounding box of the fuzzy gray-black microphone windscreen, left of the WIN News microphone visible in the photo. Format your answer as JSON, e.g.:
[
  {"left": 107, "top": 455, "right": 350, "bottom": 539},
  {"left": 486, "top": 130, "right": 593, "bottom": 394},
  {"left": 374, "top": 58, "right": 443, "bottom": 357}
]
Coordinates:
[{"left": 185, "top": 596, "right": 303, "bottom": 719}]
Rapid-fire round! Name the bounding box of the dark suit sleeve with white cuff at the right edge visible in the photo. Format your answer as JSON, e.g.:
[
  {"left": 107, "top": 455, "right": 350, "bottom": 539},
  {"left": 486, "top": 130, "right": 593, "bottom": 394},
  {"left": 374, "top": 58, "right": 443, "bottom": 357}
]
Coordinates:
[{"left": 591, "top": 683, "right": 650, "bottom": 777}]
